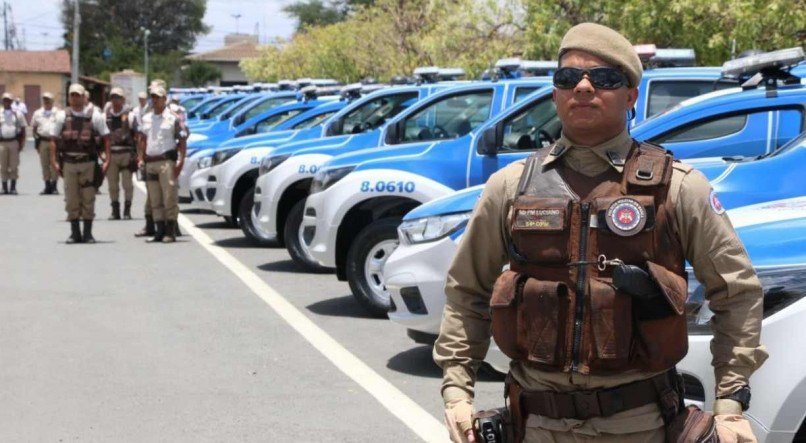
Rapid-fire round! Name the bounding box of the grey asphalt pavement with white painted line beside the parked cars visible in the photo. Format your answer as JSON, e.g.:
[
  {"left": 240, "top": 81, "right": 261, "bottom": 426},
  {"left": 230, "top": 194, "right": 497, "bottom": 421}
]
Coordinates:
[{"left": 0, "top": 141, "right": 503, "bottom": 442}]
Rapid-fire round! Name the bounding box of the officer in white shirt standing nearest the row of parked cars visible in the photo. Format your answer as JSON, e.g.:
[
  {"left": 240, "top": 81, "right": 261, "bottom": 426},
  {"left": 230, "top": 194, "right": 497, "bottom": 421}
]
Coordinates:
[{"left": 138, "top": 84, "right": 187, "bottom": 243}]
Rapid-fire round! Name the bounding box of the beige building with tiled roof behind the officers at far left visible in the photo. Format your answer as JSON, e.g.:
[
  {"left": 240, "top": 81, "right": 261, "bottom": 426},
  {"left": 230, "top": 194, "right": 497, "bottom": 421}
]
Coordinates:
[{"left": 0, "top": 50, "right": 70, "bottom": 121}]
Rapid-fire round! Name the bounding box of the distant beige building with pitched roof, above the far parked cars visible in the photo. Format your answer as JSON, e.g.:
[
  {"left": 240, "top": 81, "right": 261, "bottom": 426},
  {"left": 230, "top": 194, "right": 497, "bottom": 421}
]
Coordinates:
[{"left": 187, "top": 34, "right": 260, "bottom": 86}]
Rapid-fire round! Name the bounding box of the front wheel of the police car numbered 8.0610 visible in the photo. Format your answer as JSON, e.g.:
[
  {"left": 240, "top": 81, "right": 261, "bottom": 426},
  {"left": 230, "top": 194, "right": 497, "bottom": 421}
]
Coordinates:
[{"left": 346, "top": 218, "right": 400, "bottom": 317}]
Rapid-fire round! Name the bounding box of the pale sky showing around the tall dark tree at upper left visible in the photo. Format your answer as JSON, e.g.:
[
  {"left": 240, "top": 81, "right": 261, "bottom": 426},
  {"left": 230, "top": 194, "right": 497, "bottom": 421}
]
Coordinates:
[{"left": 7, "top": 0, "right": 295, "bottom": 52}]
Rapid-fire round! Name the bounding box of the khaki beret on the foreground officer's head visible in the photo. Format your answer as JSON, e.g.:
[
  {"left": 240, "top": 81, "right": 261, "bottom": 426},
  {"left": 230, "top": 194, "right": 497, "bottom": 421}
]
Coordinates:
[{"left": 558, "top": 23, "right": 644, "bottom": 88}]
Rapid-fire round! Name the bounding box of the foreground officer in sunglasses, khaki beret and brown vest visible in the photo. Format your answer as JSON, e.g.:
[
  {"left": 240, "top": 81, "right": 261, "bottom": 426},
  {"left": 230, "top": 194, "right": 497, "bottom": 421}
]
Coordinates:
[{"left": 434, "top": 23, "right": 767, "bottom": 442}]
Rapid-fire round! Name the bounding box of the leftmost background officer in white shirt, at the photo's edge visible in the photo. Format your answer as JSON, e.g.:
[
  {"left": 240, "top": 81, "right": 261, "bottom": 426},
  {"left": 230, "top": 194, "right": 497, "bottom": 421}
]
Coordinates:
[{"left": 0, "top": 92, "right": 27, "bottom": 194}]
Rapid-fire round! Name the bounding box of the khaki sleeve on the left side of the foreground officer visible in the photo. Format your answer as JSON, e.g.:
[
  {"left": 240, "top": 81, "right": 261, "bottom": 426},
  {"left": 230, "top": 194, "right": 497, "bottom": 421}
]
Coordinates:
[{"left": 434, "top": 164, "right": 523, "bottom": 402}]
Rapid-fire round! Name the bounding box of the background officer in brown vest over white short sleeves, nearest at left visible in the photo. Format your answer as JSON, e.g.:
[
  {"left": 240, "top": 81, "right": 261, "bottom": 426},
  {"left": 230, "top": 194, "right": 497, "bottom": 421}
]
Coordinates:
[{"left": 50, "top": 83, "right": 109, "bottom": 244}]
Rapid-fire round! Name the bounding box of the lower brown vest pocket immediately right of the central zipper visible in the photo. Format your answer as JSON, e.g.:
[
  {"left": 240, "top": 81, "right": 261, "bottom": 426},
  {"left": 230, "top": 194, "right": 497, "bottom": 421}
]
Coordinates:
[{"left": 588, "top": 278, "right": 633, "bottom": 370}]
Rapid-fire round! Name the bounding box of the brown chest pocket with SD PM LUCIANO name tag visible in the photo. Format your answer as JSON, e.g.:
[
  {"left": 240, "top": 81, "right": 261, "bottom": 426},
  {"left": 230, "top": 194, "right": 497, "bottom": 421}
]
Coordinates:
[{"left": 510, "top": 196, "right": 571, "bottom": 264}]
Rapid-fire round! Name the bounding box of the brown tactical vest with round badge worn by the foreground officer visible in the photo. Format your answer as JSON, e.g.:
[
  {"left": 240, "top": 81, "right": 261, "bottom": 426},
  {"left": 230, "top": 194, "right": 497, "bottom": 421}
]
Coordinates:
[{"left": 490, "top": 143, "right": 688, "bottom": 375}]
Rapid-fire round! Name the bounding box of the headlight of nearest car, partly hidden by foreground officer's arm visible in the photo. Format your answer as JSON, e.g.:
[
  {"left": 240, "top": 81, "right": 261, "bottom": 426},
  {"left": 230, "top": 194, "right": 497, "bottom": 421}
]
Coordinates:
[{"left": 686, "top": 266, "right": 806, "bottom": 335}]
